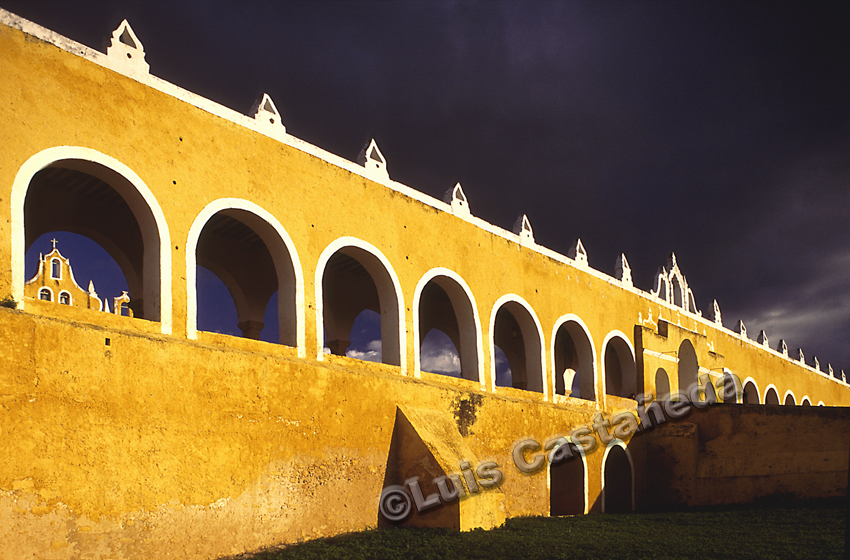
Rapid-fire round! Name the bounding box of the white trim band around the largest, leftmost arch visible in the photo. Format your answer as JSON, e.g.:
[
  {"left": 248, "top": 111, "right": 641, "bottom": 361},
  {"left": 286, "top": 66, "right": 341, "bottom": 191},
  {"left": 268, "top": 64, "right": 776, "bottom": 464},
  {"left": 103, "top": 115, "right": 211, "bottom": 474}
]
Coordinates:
[{"left": 10, "top": 146, "right": 172, "bottom": 334}]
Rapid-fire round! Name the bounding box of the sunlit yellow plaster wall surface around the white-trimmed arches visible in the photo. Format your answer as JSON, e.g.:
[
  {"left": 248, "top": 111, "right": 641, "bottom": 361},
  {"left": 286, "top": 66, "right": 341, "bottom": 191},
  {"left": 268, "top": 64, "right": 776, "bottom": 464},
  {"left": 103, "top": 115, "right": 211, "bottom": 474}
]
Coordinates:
[{"left": 0, "top": 15, "right": 848, "bottom": 558}]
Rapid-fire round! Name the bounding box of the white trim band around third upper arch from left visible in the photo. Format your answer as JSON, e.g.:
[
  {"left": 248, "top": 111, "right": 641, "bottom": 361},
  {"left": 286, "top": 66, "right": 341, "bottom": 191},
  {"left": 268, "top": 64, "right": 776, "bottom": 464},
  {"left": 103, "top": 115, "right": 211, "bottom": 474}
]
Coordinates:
[{"left": 314, "top": 237, "right": 407, "bottom": 375}]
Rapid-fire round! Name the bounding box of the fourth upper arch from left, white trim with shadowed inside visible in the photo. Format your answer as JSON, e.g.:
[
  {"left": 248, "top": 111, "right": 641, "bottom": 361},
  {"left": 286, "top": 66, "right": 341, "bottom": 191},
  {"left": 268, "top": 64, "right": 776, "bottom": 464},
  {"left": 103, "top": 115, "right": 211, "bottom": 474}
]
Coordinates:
[{"left": 413, "top": 268, "right": 484, "bottom": 385}]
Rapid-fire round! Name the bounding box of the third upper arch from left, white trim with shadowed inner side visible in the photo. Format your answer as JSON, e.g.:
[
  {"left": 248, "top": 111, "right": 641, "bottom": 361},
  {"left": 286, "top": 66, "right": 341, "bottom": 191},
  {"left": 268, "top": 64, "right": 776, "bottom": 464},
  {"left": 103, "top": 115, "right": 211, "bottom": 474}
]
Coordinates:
[{"left": 315, "top": 237, "right": 407, "bottom": 373}]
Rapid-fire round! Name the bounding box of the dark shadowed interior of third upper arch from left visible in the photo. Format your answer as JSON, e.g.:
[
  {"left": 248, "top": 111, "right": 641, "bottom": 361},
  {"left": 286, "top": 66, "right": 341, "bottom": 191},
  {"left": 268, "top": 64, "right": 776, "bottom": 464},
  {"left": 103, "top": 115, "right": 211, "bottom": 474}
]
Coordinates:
[{"left": 322, "top": 250, "right": 386, "bottom": 363}]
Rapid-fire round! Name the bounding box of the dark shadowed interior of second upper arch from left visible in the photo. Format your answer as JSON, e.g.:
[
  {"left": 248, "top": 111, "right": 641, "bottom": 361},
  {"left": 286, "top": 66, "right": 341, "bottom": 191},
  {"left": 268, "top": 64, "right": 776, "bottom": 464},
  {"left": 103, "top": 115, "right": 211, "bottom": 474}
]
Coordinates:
[{"left": 196, "top": 210, "right": 282, "bottom": 346}]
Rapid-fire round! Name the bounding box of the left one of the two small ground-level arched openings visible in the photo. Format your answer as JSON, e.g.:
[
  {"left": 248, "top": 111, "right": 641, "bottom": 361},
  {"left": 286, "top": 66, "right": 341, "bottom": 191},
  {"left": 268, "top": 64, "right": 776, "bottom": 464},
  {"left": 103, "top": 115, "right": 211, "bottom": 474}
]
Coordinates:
[{"left": 548, "top": 438, "right": 588, "bottom": 516}]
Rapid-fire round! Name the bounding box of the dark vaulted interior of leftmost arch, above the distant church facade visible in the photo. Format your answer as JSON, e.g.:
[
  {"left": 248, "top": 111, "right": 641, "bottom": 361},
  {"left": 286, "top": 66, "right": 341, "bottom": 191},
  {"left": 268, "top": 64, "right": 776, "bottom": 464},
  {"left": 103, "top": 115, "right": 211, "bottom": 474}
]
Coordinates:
[{"left": 24, "top": 166, "right": 152, "bottom": 321}]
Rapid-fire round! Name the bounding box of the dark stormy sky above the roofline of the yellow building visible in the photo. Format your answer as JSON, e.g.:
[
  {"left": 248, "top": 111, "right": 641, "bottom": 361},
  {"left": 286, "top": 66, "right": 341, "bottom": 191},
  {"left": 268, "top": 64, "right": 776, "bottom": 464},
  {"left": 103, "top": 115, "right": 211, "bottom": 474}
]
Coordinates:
[{"left": 6, "top": 0, "right": 850, "bottom": 371}]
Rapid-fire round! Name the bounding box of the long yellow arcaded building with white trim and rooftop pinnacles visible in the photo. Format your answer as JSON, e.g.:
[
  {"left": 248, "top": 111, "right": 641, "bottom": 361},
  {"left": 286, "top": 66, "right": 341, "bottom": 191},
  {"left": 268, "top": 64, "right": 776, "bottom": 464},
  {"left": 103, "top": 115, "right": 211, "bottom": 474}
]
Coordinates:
[{"left": 0, "top": 10, "right": 850, "bottom": 558}]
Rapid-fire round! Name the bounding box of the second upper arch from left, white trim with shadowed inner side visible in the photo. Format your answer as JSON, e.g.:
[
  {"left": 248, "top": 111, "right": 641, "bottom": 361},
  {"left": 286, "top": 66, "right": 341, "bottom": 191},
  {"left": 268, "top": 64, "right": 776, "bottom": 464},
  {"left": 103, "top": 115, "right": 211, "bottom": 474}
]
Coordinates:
[{"left": 186, "top": 198, "right": 306, "bottom": 352}]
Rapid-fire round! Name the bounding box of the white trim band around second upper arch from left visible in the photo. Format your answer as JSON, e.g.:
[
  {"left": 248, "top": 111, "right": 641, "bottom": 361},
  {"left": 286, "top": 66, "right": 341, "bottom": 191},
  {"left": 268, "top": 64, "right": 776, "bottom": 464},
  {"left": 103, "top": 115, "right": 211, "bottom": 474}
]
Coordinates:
[{"left": 186, "top": 198, "right": 307, "bottom": 358}]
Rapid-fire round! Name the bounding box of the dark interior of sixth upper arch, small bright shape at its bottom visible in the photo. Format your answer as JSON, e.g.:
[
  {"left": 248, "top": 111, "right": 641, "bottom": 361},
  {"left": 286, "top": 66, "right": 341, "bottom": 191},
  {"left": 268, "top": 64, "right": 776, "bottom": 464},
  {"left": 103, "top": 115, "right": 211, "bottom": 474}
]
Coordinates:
[{"left": 555, "top": 322, "right": 596, "bottom": 401}]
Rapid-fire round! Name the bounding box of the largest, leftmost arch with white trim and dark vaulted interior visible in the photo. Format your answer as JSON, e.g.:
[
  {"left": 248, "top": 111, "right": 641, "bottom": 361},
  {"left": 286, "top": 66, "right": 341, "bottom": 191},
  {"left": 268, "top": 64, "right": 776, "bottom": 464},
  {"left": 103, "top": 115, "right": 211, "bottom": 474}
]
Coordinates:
[{"left": 11, "top": 146, "right": 172, "bottom": 334}]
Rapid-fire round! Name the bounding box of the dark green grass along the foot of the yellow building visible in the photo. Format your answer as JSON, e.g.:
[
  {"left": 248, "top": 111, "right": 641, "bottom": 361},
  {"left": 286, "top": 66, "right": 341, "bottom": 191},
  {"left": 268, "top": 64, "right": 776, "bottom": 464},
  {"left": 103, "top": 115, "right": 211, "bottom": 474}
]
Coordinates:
[{"left": 224, "top": 506, "right": 846, "bottom": 560}]
